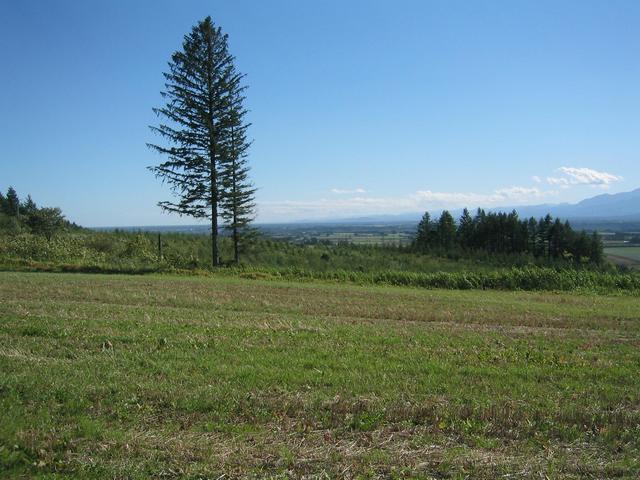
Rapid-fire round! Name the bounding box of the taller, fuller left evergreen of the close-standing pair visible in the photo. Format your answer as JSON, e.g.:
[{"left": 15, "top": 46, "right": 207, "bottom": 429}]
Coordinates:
[{"left": 149, "top": 17, "right": 248, "bottom": 266}]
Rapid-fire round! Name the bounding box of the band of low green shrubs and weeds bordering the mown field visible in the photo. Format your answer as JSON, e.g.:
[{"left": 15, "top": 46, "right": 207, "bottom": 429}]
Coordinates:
[{"left": 0, "top": 231, "right": 640, "bottom": 294}]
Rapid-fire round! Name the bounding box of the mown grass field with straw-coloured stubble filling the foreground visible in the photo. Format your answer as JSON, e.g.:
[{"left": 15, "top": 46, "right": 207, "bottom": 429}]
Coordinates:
[{"left": 0, "top": 273, "right": 640, "bottom": 479}]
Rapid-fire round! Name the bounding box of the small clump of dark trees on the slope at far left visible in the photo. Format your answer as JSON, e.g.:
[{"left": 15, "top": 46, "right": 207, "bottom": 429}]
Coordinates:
[{"left": 0, "top": 187, "right": 79, "bottom": 240}]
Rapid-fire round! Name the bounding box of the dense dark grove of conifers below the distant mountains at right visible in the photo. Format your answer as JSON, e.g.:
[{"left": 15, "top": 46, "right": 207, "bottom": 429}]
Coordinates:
[{"left": 414, "top": 208, "right": 604, "bottom": 263}]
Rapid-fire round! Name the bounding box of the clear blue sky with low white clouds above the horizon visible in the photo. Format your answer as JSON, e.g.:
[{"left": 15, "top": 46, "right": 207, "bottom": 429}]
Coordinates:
[{"left": 0, "top": 0, "right": 640, "bottom": 226}]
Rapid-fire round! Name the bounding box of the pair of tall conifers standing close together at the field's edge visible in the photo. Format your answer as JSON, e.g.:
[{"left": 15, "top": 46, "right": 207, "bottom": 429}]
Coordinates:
[{"left": 148, "top": 17, "right": 255, "bottom": 266}]
